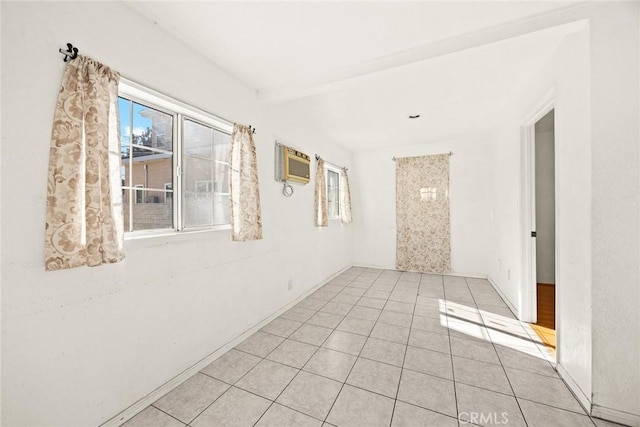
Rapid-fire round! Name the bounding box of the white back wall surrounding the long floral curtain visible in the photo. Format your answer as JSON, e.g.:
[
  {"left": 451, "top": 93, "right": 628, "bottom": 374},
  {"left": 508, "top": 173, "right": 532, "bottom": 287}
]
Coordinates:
[{"left": 351, "top": 137, "right": 490, "bottom": 277}]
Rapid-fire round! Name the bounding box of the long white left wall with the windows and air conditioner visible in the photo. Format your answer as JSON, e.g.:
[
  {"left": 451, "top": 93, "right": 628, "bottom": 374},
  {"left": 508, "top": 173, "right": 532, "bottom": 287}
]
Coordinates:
[{"left": 1, "top": 2, "right": 352, "bottom": 426}]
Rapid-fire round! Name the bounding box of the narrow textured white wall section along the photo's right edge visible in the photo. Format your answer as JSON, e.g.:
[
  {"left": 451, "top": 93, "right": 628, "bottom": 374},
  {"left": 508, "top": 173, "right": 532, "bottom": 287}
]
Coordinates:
[{"left": 590, "top": 2, "right": 640, "bottom": 425}]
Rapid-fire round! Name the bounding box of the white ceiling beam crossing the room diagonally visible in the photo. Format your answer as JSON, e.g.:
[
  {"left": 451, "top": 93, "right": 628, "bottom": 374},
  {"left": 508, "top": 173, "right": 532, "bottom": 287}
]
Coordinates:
[{"left": 257, "top": 2, "right": 590, "bottom": 102}]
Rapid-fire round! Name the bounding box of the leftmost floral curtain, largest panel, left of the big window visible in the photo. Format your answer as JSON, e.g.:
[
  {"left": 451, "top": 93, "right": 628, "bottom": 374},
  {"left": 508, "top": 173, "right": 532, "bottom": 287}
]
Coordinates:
[{"left": 45, "top": 56, "right": 124, "bottom": 270}]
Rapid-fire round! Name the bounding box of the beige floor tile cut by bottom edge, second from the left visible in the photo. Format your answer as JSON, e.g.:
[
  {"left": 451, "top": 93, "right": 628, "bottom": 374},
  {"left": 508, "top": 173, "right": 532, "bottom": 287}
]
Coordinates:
[{"left": 190, "top": 387, "right": 271, "bottom": 427}]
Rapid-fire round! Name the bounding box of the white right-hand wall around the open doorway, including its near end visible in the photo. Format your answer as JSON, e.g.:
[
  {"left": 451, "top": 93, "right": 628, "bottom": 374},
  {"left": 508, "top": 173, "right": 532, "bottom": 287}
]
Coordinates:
[{"left": 490, "top": 2, "right": 640, "bottom": 425}]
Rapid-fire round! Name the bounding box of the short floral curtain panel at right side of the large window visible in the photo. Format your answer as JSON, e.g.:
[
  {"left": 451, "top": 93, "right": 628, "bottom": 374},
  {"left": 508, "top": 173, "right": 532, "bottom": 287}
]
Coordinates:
[{"left": 229, "top": 124, "right": 262, "bottom": 241}]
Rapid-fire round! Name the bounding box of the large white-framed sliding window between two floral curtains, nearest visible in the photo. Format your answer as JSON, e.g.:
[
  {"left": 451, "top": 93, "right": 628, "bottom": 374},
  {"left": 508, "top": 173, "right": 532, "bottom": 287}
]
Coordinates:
[{"left": 118, "top": 82, "right": 232, "bottom": 236}]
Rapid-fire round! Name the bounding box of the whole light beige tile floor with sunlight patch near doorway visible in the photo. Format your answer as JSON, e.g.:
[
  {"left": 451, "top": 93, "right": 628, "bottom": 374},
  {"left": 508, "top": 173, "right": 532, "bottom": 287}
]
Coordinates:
[{"left": 125, "top": 267, "right": 616, "bottom": 427}]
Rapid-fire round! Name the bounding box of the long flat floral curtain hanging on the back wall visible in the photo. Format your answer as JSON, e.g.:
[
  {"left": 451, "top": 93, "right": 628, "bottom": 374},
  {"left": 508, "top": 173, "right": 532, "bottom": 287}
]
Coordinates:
[{"left": 396, "top": 154, "right": 451, "bottom": 273}]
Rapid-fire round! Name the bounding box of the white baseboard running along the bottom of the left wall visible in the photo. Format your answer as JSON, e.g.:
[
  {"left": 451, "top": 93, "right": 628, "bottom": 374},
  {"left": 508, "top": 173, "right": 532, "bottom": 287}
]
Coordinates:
[{"left": 100, "top": 266, "right": 351, "bottom": 427}]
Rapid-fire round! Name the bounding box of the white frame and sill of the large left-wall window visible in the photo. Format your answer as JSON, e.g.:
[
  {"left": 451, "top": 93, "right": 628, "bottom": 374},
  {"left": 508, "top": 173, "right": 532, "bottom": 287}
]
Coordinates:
[{"left": 118, "top": 78, "right": 233, "bottom": 240}]
